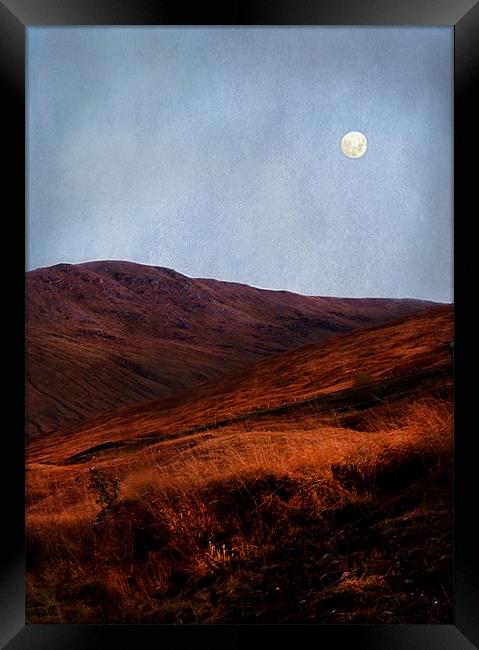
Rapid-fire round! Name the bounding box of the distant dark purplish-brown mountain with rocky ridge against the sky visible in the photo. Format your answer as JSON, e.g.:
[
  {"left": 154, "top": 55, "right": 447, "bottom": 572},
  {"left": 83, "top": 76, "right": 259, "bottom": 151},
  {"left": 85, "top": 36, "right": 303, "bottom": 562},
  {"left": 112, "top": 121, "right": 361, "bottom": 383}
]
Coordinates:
[{"left": 26, "top": 261, "right": 433, "bottom": 437}]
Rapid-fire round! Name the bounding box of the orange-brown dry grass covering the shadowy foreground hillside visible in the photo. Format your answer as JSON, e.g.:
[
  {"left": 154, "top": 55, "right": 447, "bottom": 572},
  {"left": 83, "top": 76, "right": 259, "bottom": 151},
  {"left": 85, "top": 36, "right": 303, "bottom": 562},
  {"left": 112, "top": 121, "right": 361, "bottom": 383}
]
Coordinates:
[{"left": 27, "top": 397, "right": 452, "bottom": 623}]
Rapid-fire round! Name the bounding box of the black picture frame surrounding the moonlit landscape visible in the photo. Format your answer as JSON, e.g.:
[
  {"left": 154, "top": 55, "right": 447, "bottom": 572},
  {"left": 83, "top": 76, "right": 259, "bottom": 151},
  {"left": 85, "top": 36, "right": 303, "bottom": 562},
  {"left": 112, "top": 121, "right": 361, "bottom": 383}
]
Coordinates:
[{"left": 0, "top": 0, "right": 479, "bottom": 650}]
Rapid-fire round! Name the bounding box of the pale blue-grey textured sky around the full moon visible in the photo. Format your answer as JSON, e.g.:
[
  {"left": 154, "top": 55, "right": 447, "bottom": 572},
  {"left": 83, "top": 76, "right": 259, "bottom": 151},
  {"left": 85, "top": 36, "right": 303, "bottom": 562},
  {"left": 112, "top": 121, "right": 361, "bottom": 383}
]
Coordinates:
[{"left": 26, "top": 27, "right": 453, "bottom": 302}]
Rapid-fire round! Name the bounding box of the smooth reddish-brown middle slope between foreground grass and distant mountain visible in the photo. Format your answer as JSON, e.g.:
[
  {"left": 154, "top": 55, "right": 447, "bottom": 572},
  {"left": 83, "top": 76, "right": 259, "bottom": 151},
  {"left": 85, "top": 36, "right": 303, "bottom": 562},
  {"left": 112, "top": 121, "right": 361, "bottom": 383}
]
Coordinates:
[{"left": 29, "top": 306, "right": 453, "bottom": 464}]
